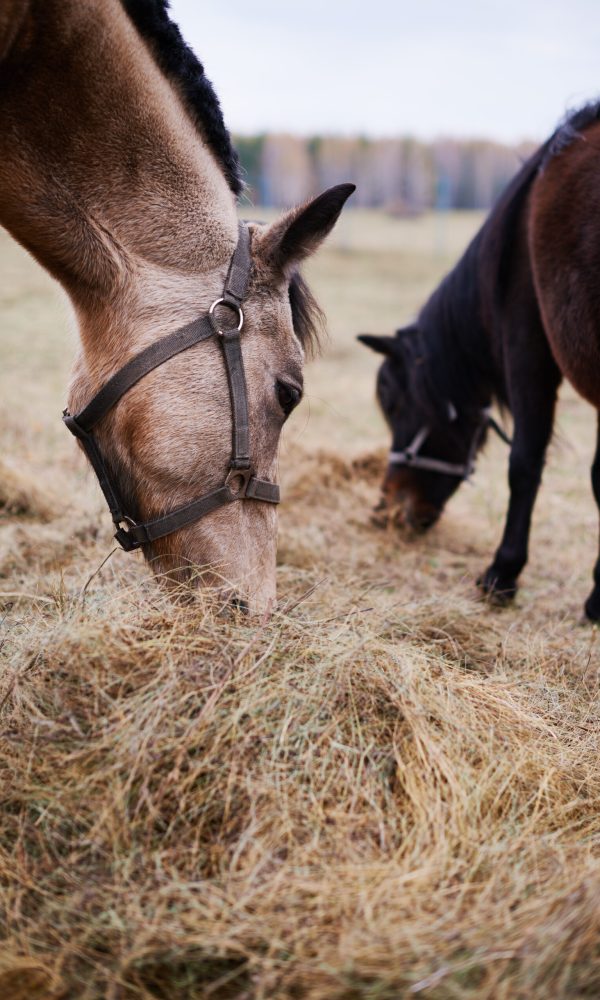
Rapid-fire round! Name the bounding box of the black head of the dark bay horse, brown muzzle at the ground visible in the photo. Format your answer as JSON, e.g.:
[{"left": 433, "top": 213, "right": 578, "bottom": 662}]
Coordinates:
[{"left": 358, "top": 326, "right": 488, "bottom": 531}]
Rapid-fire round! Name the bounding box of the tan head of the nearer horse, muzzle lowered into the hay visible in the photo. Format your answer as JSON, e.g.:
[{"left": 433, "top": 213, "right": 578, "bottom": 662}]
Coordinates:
[{"left": 67, "top": 184, "right": 354, "bottom": 606}]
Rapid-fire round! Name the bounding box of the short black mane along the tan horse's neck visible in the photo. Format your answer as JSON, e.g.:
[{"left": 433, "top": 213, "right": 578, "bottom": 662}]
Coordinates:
[{"left": 121, "top": 0, "right": 243, "bottom": 195}]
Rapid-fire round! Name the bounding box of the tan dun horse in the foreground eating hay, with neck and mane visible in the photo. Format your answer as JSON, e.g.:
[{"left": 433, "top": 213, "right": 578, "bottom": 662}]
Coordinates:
[{"left": 0, "top": 0, "right": 353, "bottom": 606}]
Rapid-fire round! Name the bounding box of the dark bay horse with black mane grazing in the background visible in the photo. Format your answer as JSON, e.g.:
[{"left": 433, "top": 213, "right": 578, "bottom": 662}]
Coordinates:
[{"left": 359, "top": 104, "right": 600, "bottom": 620}]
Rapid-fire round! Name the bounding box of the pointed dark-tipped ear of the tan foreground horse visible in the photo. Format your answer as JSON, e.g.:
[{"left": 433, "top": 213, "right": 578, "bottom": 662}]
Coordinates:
[{"left": 259, "top": 184, "right": 356, "bottom": 272}]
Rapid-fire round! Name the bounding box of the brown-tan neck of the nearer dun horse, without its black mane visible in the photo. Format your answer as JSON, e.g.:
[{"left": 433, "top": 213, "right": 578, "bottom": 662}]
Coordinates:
[{"left": 0, "top": 0, "right": 236, "bottom": 356}]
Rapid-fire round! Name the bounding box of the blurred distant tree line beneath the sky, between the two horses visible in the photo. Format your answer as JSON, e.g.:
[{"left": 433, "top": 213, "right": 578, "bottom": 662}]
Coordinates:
[{"left": 235, "top": 134, "right": 536, "bottom": 214}]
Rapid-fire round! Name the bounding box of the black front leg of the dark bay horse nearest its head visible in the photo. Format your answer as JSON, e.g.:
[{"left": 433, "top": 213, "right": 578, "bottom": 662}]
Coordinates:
[{"left": 477, "top": 338, "right": 560, "bottom": 601}]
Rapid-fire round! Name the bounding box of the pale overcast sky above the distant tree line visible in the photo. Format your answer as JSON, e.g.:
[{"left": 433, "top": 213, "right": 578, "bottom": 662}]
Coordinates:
[{"left": 171, "top": 0, "right": 600, "bottom": 142}]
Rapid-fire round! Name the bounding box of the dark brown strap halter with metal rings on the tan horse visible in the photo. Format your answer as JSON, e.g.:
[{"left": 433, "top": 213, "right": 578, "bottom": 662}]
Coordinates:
[{"left": 63, "top": 222, "right": 279, "bottom": 552}]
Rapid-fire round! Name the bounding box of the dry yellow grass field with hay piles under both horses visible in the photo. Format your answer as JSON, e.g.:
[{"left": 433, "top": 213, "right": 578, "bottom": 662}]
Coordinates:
[{"left": 0, "top": 205, "right": 600, "bottom": 1000}]
